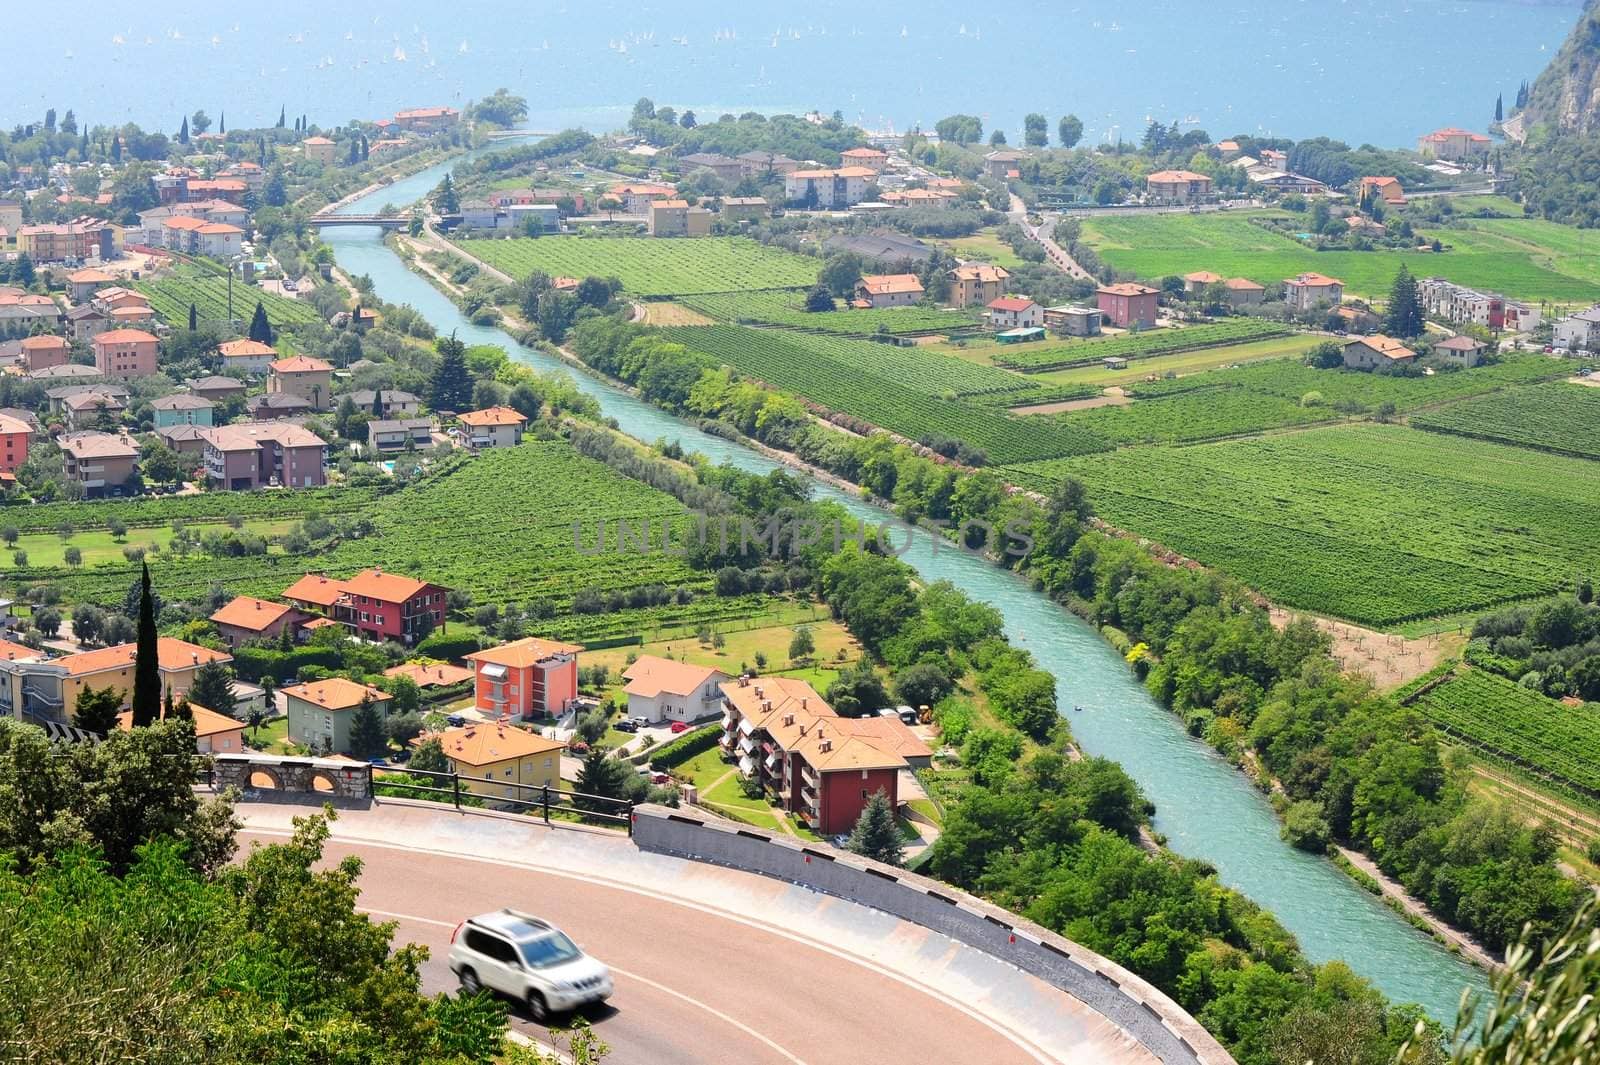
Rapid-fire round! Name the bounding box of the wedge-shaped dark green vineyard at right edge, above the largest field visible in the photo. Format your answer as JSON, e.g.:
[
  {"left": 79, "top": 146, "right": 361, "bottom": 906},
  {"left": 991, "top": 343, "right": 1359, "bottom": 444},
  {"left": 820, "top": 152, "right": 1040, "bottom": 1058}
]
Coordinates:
[{"left": 1411, "top": 382, "right": 1600, "bottom": 459}]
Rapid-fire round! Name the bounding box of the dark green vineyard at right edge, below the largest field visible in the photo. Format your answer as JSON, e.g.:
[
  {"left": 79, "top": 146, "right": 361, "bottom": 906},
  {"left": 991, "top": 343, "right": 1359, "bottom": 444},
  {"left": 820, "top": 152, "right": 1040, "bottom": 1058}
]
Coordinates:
[{"left": 1413, "top": 668, "right": 1600, "bottom": 798}]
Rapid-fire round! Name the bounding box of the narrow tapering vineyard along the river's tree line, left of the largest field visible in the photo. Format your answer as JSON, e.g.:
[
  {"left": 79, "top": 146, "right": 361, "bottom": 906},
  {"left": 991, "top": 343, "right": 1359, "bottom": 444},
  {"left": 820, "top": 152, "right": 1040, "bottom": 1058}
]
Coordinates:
[{"left": 667, "top": 326, "right": 1107, "bottom": 462}]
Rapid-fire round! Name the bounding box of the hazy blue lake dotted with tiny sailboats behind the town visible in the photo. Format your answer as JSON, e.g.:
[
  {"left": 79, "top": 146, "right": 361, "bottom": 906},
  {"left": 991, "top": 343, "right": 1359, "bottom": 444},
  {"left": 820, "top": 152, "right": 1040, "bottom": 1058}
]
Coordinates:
[{"left": 12, "top": 0, "right": 1579, "bottom": 146}]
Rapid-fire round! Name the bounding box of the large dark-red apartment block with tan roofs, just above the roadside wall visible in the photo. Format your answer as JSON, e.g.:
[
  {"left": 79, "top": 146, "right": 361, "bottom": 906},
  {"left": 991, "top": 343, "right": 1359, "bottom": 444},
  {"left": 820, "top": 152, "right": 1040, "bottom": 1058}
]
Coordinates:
[{"left": 722, "top": 676, "right": 930, "bottom": 836}]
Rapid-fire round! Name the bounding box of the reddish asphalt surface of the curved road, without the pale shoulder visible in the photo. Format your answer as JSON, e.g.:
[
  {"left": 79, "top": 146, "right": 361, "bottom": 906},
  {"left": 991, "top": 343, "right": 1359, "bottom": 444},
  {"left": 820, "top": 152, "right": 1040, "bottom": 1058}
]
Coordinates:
[{"left": 236, "top": 832, "right": 1056, "bottom": 1065}]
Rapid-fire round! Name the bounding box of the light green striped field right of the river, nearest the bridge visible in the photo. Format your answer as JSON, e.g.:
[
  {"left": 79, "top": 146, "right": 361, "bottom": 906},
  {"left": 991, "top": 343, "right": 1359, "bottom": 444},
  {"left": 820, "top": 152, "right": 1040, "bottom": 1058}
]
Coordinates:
[{"left": 454, "top": 237, "right": 821, "bottom": 296}]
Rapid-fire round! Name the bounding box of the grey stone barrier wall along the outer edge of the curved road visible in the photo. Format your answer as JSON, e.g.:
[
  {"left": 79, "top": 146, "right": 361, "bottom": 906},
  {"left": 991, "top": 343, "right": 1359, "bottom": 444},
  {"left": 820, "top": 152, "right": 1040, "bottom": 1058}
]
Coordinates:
[{"left": 634, "top": 806, "right": 1234, "bottom": 1065}]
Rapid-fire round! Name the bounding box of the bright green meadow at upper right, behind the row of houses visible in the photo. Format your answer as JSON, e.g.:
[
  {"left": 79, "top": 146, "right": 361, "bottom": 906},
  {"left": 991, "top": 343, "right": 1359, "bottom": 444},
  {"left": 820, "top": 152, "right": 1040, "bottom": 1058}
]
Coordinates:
[{"left": 1083, "top": 213, "right": 1600, "bottom": 304}]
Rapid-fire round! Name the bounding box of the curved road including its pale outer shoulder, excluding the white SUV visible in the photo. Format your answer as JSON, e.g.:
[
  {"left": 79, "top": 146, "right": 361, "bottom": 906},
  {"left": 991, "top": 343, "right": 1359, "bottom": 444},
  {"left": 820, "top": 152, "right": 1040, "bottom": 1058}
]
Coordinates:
[{"left": 240, "top": 804, "right": 1154, "bottom": 1065}]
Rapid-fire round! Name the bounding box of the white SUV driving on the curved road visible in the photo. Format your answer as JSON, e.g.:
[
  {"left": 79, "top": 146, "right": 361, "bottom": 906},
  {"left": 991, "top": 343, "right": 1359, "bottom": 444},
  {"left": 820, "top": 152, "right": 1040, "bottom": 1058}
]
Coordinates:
[{"left": 450, "top": 910, "right": 611, "bottom": 1020}]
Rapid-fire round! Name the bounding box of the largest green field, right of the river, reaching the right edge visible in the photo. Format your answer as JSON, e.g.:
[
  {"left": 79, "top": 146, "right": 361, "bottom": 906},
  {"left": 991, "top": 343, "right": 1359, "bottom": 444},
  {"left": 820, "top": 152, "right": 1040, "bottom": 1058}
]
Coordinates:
[{"left": 1006, "top": 422, "right": 1600, "bottom": 625}]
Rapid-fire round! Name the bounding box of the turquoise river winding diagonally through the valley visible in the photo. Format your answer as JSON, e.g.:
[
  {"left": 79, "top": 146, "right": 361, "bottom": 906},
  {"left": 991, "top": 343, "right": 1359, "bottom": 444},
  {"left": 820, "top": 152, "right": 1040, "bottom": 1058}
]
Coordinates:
[{"left": 325, "top": 145, "right": 1486, "bottom": 1027}]
